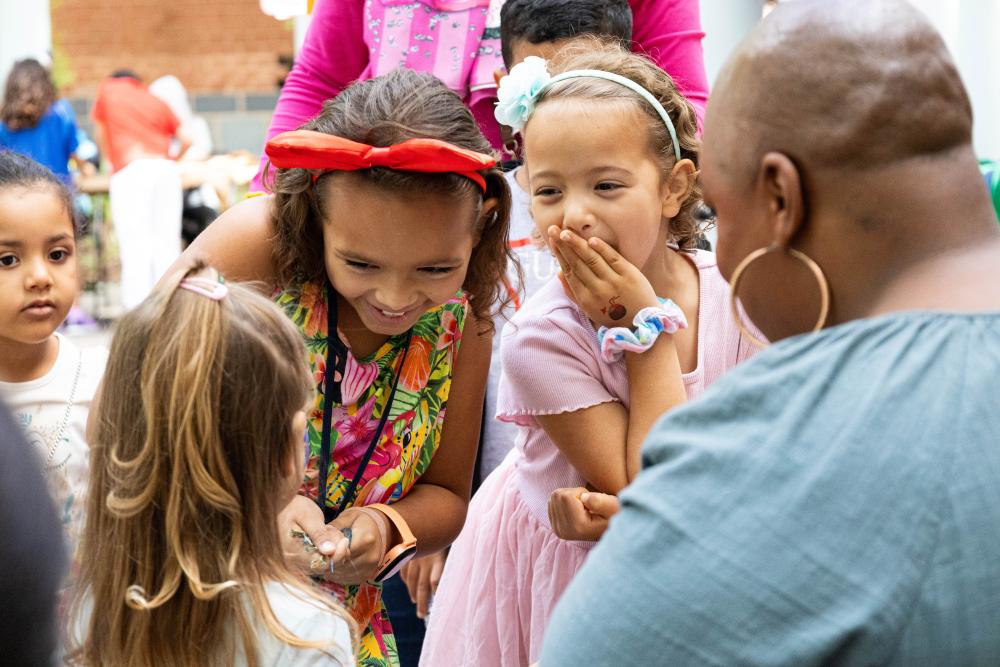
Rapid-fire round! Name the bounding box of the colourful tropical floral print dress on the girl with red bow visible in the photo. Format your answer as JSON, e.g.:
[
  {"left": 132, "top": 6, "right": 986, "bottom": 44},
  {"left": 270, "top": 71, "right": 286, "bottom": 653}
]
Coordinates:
[{"left": 275, "top": 282, "right": 468, "bottom": 667}]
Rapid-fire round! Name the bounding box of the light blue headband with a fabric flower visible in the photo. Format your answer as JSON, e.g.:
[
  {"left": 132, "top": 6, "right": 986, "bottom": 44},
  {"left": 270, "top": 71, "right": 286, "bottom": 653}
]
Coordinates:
[{"left": 494, "top": 56, "right": 681, "bottom": 160}]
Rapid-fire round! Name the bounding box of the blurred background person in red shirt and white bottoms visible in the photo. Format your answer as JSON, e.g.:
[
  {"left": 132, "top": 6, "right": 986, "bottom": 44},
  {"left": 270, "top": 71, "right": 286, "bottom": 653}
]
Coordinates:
[{"left": 91, "top": 70, "right": 191, "bottom": 309}]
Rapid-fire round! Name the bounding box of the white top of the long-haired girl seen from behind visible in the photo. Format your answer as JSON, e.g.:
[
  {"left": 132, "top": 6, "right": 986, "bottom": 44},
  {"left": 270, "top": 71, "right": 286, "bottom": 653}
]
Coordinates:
[{"left": 71, "top": 581, "right": 355, "bottom": 667}]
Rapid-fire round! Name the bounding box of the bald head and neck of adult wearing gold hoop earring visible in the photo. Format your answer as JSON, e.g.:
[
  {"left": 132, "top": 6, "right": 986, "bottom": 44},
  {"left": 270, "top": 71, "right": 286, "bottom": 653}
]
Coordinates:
[{"left": 701, "top": 0, "right": 997, "bottom": 340}]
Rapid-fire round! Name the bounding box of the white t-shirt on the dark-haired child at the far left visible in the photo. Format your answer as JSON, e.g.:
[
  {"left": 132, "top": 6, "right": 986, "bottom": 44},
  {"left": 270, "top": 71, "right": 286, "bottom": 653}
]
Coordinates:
[{"left": 0, "top": 333, "right": 108, "bottom": 553}]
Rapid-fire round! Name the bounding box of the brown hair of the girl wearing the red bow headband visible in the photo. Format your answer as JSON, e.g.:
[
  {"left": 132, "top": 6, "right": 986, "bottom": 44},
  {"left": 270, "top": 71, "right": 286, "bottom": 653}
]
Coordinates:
[{"left": 265, "top": 68, "right": 517, "bottom": 328}]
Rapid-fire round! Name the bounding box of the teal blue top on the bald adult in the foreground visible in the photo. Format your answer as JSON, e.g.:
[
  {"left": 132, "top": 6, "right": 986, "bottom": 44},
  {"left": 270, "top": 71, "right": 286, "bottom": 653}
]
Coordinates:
[{"left": 541, "top": 312, "right": 1000, "bottom": 667}]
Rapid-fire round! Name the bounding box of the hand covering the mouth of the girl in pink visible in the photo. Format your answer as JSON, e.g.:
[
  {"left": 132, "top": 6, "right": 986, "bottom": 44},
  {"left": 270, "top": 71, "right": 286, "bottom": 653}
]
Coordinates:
[{"left": 548, "top": 225, "right": 660, "bottom": 327}]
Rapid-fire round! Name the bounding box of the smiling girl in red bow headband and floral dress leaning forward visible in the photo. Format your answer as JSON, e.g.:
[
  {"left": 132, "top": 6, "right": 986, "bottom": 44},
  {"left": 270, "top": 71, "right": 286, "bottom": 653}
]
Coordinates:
[{"left": 162, "top": 69, "right": 510, "bottom": 665}]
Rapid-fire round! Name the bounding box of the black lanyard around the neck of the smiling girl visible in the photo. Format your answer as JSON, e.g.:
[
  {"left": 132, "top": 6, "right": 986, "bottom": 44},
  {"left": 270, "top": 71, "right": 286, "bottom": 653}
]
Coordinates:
[{"left": 317, "top": 281, "right": 413, "bottom": 523}]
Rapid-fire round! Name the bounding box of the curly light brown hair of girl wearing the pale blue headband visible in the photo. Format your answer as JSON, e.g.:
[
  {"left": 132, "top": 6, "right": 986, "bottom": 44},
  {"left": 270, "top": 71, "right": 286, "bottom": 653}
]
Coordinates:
[{"left": 538, "top": 35, "right": 704, "bottom": 251}]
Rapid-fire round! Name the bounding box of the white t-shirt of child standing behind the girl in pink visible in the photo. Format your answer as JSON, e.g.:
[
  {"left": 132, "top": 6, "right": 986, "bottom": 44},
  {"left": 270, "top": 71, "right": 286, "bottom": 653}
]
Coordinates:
[{"left": 479, "top": 167, "right": 559, "bottom": 479}]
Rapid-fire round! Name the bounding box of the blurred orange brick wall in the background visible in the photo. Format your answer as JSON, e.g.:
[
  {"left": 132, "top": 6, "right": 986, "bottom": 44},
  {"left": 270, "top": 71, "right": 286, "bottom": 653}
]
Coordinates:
[{"left": 51, "top": 0, "right": 293, "bottom": 97}]
